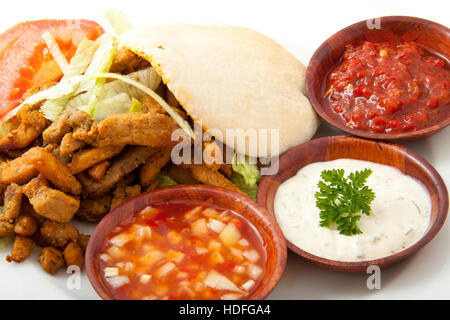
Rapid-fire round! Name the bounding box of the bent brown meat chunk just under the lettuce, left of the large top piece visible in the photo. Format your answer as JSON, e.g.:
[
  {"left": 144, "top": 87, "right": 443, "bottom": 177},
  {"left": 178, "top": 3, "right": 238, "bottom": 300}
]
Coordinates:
[{"left": 42, "top": 108, "right": 93, "bottom": 145}]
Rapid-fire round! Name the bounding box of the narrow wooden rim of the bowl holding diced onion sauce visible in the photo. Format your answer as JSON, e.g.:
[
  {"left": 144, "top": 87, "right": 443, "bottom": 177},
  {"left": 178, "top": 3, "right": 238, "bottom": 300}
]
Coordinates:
[{"left": 85, "top": 184, "right": 287, "bottom": 300}]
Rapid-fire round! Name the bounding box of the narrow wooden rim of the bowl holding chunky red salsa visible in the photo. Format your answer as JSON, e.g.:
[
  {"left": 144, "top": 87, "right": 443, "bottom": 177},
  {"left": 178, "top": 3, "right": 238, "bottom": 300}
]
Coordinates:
[{"left": 306, "top": 15, "right": 450, "bottom": 141}]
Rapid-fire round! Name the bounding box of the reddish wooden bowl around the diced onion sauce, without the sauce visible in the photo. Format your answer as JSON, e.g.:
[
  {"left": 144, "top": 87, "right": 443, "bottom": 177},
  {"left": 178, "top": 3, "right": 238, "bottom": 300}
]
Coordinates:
[{"left": 86, "top": 185, "right": 287, "bottom": 300}]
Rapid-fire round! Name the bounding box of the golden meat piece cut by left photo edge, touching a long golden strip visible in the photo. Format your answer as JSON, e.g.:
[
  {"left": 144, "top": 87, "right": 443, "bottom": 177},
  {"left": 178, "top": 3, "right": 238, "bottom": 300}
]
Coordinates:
[{"left": 0, "top": 157, "right": 38, "bottom": 184}]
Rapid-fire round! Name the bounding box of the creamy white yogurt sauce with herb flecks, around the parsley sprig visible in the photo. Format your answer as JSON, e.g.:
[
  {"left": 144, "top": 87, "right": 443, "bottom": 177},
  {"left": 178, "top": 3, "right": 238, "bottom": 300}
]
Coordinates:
[{"left": 274, "top": 159, "right": 431, "bottom": 262}]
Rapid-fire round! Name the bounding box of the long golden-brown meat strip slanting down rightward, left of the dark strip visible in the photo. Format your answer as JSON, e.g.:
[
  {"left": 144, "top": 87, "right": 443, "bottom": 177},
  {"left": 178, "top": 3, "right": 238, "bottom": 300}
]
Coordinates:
[{"left": 22, "top": 147, "right": 81, "bottom": 195}]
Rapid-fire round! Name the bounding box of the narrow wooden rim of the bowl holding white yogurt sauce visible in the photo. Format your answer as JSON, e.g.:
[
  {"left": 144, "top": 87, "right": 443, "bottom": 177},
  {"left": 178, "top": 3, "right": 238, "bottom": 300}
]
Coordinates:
[{"left": 257, "top": 135, "right": 449, "bottom": 273}]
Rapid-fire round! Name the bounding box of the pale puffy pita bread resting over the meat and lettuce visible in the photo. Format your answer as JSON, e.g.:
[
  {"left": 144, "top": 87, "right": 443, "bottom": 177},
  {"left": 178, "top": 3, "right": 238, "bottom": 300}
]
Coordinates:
[{"left": 120, "top": 24, "right": 319, "bottom": 157}]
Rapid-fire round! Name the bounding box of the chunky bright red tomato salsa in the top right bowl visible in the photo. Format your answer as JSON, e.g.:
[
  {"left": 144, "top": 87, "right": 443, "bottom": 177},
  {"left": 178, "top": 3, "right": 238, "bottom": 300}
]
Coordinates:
[{"left": 325, "top": 42, "right": 450, "bottom": 133}]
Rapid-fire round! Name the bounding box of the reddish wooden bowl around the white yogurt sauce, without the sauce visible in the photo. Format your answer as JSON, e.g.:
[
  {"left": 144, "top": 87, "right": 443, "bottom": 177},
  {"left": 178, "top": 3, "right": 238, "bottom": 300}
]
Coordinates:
[{"left": 257, "top": 136, "right": 448, "bottom": 273}]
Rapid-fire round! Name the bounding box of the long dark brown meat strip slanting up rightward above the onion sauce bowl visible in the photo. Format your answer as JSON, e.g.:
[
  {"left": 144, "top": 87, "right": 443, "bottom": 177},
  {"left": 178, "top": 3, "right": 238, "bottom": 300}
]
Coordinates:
[{"left": 77, "top": 146, "right": 156, "bottom": 199}]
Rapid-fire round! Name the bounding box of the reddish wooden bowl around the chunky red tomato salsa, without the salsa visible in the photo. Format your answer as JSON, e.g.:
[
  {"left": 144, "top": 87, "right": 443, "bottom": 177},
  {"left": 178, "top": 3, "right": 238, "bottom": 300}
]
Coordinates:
[{"left": 306, "top": 16, "right": 450, "bottom": 141}]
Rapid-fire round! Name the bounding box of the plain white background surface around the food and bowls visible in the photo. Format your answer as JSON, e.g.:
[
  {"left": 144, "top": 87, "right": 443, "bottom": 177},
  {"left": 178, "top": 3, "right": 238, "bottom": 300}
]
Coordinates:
[{"left": 0, "top": 0, "right": 450, "bottom": 299}]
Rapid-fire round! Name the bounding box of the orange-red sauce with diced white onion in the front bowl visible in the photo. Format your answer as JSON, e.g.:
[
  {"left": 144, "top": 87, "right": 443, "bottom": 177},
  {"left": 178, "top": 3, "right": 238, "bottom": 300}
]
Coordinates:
[{"left": 96, "top": 202, "right": 267, "bottom": 300}]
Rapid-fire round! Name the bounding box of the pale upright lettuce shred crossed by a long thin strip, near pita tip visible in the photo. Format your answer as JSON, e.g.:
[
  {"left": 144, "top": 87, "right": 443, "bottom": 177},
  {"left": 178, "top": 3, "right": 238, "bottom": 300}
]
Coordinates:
[{"left": 85, "top": 33, "right": 116, "bottom": 117}]
